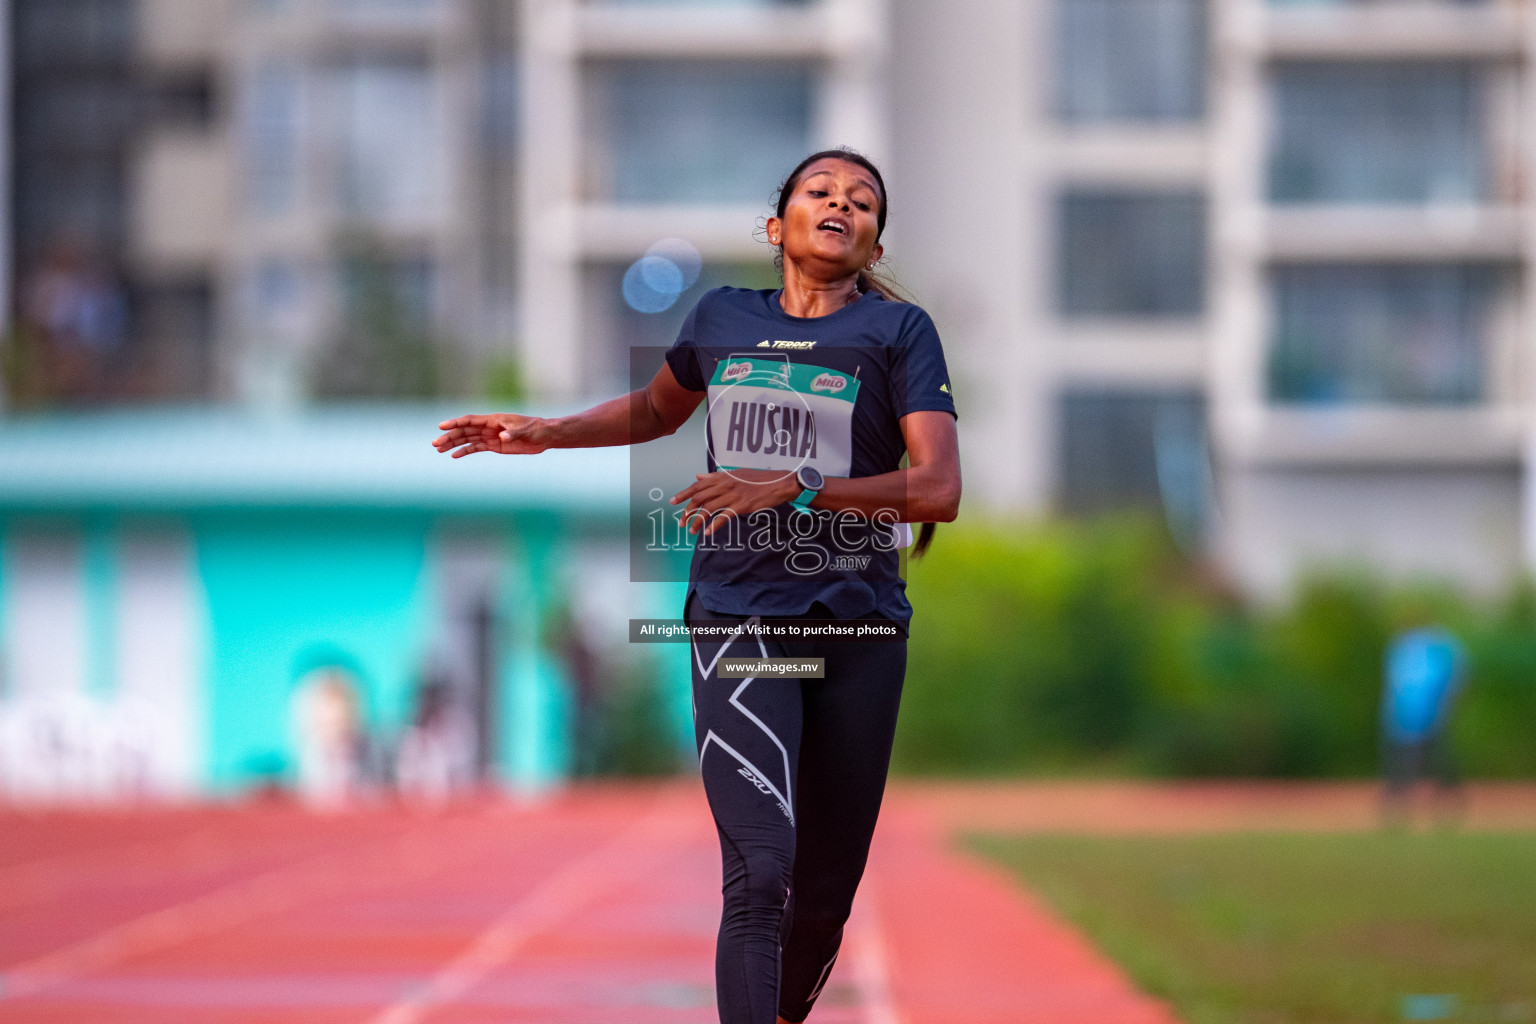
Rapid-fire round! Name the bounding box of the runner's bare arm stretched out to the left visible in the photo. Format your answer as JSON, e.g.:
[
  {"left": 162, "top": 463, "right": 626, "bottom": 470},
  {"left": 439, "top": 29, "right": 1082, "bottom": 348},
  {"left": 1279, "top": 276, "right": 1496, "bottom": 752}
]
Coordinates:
[{"left": 432, "top": 362, "right": 703, "bottom": 459}]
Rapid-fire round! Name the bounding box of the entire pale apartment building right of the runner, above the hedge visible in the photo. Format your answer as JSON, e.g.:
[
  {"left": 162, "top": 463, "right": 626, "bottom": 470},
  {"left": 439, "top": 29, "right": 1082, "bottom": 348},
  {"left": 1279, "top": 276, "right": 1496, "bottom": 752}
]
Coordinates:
[{"left": 892, "top": 0, "right": 1536, "bottom": 596}]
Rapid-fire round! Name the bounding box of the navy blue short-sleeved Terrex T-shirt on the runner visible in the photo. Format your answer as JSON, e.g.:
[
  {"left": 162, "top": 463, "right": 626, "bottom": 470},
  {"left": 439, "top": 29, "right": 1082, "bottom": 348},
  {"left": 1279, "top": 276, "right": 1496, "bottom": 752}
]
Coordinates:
[{"left": 667, "top": 289, "right": 955, "bottom": 629}]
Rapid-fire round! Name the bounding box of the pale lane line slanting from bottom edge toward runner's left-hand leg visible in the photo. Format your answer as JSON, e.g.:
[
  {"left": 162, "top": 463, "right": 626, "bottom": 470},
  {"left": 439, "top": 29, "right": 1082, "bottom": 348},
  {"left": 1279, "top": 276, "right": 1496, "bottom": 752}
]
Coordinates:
[{"left": 369, "top": 795, "right": 687, "bottom": 1024}]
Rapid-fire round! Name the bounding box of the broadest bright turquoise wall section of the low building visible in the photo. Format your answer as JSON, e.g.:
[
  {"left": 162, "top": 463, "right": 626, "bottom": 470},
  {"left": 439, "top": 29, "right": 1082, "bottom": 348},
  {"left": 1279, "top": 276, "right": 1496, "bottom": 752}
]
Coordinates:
[{"left": 195, "top": 513, "right": 432, "bottom": 792}]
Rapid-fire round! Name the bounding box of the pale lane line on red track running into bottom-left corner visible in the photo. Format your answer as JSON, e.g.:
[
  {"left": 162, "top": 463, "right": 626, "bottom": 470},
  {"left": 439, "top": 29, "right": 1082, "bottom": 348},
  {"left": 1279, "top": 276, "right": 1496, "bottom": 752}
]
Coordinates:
[{"left": 0, "top": 823, "right": 506, "bottom": 1003}]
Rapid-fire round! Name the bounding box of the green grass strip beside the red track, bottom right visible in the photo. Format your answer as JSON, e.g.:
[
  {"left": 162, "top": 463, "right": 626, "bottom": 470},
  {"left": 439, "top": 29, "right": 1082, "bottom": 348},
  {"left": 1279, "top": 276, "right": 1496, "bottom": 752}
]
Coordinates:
[{"left": 968, "top": 832, "right": 1536, "bottom": 1024}]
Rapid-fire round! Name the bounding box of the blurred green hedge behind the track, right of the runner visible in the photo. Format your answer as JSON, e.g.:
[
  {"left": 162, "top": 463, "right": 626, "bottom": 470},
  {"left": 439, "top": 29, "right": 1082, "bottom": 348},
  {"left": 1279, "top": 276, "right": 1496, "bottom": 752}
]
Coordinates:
[{"left": 895, "top": 519, "right": 1536, "bottom": 777}]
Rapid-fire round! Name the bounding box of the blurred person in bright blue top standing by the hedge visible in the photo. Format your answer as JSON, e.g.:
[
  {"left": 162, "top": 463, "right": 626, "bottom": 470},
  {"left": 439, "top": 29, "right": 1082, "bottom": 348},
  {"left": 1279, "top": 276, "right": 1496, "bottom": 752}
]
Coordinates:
[{"left": 1381, "top": 626, "right": 1467, "bottom": 823}]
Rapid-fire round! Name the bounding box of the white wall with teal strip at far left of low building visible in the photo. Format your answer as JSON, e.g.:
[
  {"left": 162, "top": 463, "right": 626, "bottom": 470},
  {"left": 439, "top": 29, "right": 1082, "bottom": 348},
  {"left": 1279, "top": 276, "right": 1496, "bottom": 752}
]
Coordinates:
[{"left": 0, "top": 530, "right": 206, "bottom": 801}]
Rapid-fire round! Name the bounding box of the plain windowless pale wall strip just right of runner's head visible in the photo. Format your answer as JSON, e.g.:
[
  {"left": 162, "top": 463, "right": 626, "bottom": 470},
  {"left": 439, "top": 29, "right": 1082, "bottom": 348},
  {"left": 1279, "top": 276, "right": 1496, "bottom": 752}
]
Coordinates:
[{"left": 886, "top": 0, "right": 1052, "bottom": 513}]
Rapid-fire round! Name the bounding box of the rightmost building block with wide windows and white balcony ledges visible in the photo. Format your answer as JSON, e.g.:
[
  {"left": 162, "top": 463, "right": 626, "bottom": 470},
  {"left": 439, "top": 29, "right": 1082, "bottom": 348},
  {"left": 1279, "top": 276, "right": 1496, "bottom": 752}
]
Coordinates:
[{"left": 1207, "top": 2, "right": 1536, "bottom": 590}]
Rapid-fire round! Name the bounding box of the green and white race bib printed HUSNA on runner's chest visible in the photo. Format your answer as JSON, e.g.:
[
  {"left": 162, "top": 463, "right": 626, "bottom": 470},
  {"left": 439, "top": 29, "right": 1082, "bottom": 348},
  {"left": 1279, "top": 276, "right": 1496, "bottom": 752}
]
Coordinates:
[{"left": 710, "top": 356, "right": 859, "bottom": 476}]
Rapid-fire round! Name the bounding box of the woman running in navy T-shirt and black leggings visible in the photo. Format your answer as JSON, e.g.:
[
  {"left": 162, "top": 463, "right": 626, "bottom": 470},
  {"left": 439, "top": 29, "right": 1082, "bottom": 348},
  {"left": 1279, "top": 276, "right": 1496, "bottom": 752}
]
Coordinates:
[{"left": 433, "top": 149, "right": 960, "bottom": 1024}]
